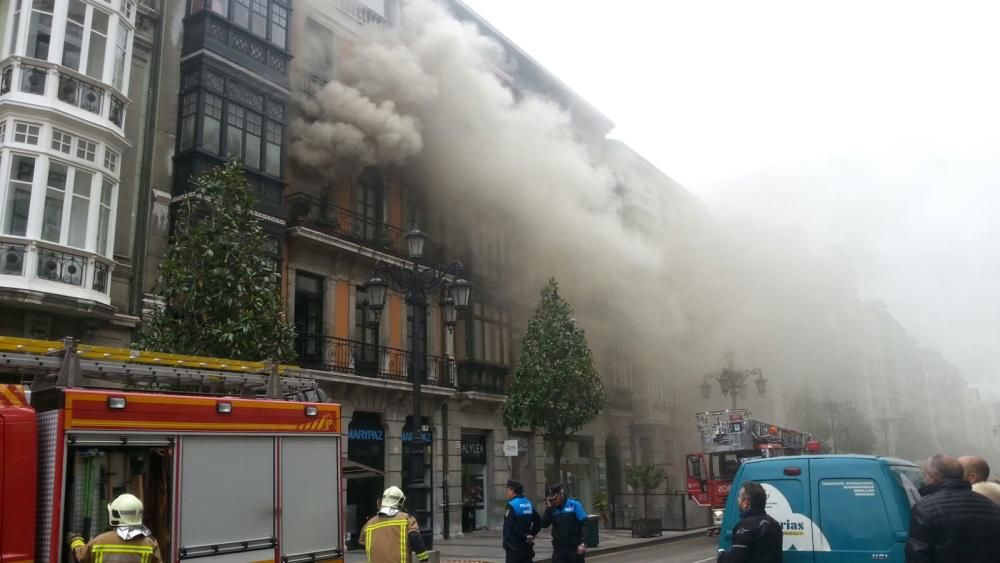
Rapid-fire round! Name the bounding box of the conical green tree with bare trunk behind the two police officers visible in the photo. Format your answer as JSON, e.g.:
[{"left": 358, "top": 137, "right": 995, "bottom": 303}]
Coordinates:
[{"left": 503, "top": 278, "right": 604, "bottom": 482}]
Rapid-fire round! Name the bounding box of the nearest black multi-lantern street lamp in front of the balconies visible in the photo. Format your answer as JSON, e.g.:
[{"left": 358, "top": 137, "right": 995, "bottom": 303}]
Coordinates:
[{"left": 367, "top": 227, "right": 472, "bottom": 536}]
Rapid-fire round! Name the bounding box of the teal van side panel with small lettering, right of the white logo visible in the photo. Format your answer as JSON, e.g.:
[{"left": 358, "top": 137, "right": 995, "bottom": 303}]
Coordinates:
[{"left": 812, "top": 458, "right": 903, "bottom": 563}]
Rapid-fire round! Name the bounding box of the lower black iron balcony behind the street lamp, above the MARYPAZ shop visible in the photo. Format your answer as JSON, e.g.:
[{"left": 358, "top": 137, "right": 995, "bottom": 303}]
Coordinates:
[{"left": 295, "top": 333, "right": 455, "bottom": 388}]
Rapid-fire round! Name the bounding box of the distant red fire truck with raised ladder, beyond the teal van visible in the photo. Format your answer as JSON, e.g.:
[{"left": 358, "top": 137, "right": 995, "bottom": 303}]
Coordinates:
[{"left": 687, "top": 409, "right": 819, "bottom": 526}]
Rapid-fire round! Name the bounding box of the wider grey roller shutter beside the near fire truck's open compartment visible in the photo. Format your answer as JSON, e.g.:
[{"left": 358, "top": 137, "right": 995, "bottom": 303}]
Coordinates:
[{"left": 179, "top": 436, "right": 274, "bottom": 560}]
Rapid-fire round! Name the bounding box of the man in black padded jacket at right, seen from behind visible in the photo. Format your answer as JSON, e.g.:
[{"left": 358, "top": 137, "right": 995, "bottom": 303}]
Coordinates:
[{"left": 906, "top": 454, "right": 1000, "bottom": 563}]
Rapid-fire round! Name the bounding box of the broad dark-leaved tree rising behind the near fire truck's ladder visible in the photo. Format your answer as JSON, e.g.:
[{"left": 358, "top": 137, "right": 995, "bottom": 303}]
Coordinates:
[{"left": 139, "top": 162, "right": 295, "bottom": 361}]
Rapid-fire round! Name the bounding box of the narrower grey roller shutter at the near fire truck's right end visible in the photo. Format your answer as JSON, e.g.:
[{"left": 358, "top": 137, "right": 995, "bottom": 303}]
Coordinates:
[{"left": 281, "top": 436, "right": 343, "bottom": 560}]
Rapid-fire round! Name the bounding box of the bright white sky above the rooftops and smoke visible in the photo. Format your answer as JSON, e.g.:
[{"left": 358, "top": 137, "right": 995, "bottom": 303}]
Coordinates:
[{"left": 465, "top": 0, "right": 1000, "bottom": 398}]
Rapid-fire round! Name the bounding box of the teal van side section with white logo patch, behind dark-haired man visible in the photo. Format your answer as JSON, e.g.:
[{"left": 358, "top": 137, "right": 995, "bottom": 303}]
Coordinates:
[{"left": 719, "top": 457, "right": 816, "bottom": 563}]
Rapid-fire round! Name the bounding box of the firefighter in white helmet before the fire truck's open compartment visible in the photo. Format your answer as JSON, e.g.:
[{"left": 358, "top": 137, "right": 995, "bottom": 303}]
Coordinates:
[{"left": 66, "top": 494, "right": 163, "bottom": 563}]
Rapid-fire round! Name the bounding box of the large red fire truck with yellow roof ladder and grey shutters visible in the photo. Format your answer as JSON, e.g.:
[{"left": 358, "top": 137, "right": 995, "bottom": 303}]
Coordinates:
[{"left": 0, "top": 337, "right": 344, "bottom": 563}]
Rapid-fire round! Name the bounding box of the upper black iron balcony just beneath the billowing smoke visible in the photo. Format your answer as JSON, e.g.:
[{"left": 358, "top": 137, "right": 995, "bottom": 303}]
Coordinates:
[{"left": 285, "top": 193, "right": 445, "bottom": 263}]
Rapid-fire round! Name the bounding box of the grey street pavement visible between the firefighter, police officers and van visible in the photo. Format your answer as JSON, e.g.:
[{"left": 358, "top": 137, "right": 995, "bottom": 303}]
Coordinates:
[{"left": 345, "top": 529, "right": 718, "bottom": 563}]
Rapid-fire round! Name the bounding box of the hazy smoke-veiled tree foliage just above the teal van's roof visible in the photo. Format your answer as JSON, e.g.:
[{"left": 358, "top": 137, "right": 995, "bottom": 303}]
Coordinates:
[{"left": 788, "top": 392, "right": 876, "bottom": 454}]
